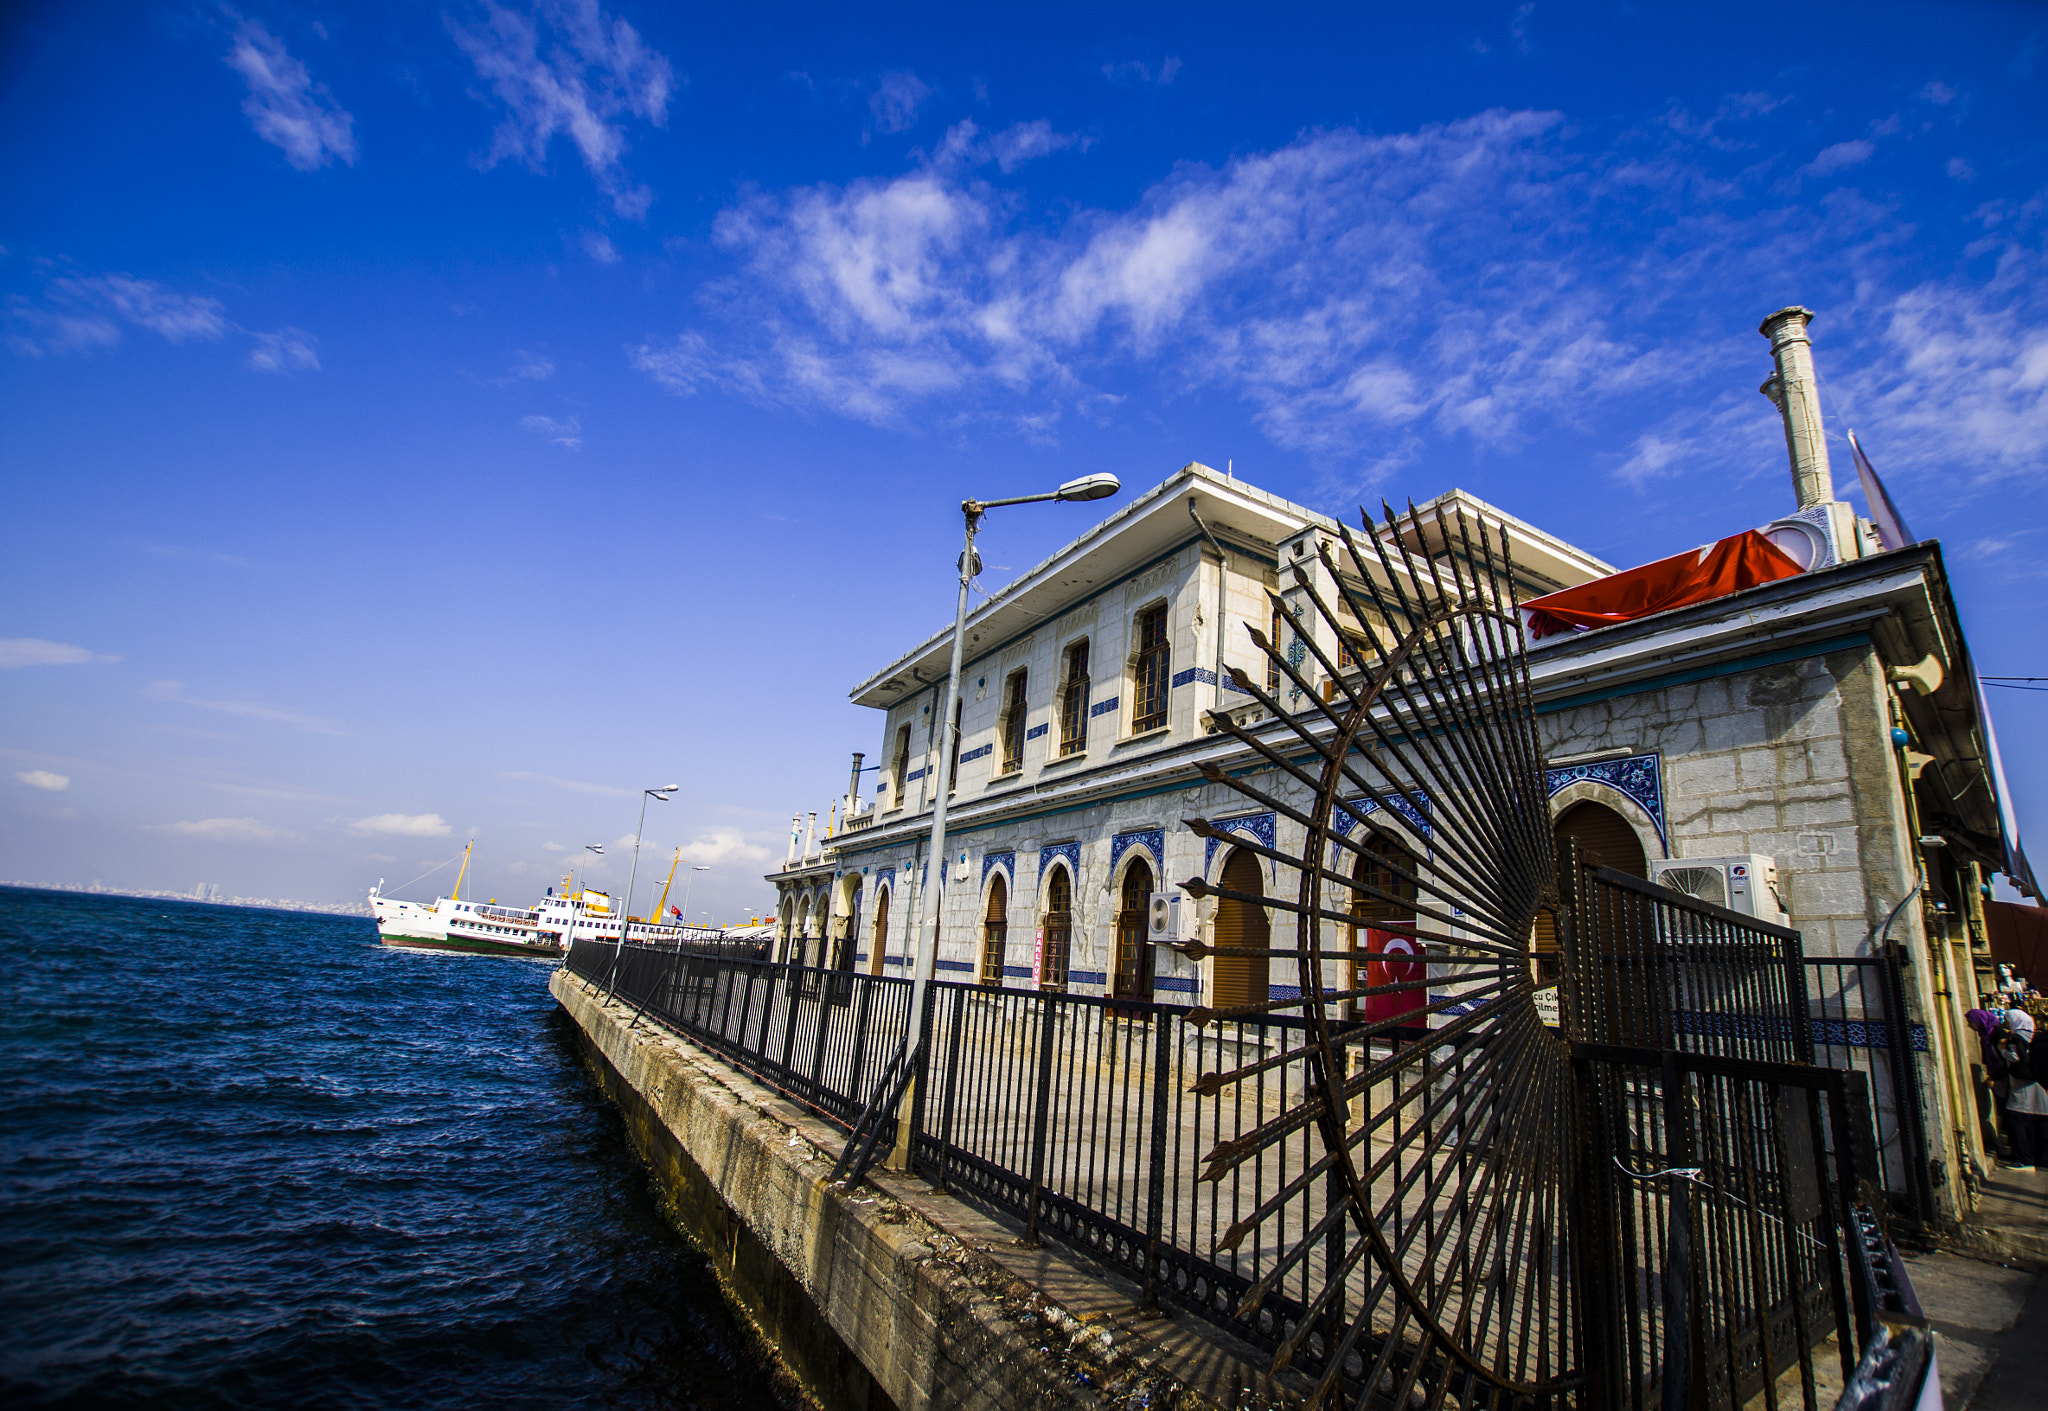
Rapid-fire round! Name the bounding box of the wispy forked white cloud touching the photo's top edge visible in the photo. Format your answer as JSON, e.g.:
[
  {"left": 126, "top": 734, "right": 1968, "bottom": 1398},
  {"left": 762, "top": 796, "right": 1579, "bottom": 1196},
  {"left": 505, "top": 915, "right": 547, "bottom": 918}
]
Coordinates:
[{"left": 449, "top": 0, "right": 676, "bottom": 219}]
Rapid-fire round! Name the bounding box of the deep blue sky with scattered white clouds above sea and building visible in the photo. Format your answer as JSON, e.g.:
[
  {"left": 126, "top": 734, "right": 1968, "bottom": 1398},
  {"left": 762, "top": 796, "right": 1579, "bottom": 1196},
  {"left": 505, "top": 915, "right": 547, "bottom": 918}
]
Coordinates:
[{"left": 0, "top": 0, "right": 2048, "bottom": 917}]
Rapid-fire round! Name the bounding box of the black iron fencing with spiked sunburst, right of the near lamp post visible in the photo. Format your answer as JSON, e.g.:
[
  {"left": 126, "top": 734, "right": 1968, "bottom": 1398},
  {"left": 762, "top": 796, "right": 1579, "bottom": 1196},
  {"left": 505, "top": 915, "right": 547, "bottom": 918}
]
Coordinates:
[{"left": 802, "top": 506, "right": 1900, "bottom": 1411}]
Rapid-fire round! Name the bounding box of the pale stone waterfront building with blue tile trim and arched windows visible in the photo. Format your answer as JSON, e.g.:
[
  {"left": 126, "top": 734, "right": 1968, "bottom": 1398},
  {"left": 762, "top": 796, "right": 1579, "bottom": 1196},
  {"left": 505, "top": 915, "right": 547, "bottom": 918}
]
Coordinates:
[{"left": 770, "top": 315, "right": 2032, "bottom": 1216}]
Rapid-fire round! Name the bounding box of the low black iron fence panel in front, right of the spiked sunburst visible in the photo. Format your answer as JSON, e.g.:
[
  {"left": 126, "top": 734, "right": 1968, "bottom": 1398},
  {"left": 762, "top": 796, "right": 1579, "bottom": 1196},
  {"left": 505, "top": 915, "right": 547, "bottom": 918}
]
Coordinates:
[{"left": 1573, "top": 1044, "right": 1872, "bottom": 1411}]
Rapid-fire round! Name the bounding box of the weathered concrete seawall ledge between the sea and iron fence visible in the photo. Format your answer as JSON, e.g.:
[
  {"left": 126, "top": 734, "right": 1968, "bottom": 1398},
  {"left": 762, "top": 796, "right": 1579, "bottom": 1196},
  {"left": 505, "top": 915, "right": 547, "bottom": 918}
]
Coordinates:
[{"left": 549, "top": 969, "right": 1309, "bottom": 1411}]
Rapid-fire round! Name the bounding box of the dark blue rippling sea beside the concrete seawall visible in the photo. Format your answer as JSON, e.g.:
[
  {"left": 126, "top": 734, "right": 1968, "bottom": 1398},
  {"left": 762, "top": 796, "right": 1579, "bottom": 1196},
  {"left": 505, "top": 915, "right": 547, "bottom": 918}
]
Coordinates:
[{"left": 0, "top": 889, "right": 803, "bottom": 1409}]
